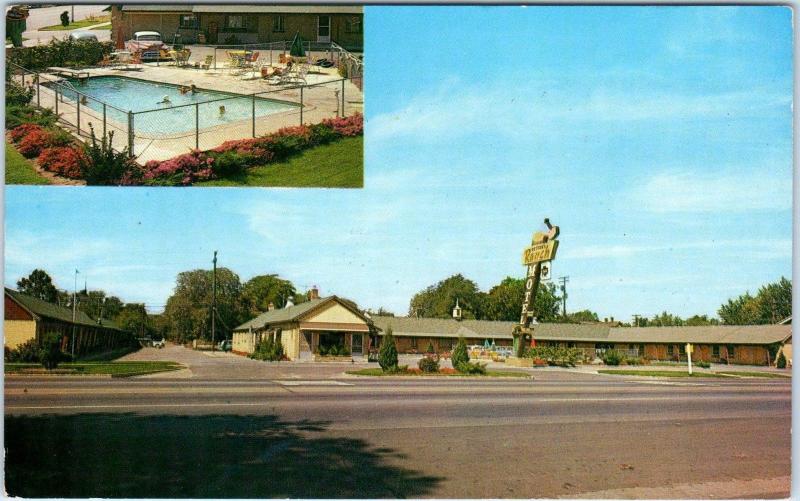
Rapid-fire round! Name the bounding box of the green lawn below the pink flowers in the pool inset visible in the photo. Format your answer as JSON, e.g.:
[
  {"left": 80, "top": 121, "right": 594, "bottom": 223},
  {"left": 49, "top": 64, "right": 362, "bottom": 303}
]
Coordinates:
[{"left": 196, "top": 136, "right": 364, "bottom": 188}]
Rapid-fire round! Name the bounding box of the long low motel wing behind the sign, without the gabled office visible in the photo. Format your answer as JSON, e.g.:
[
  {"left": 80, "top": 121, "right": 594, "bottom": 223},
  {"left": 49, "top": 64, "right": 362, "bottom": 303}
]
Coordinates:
[{"left": 372, "top": 316, "right": 792, "bottom": 365}]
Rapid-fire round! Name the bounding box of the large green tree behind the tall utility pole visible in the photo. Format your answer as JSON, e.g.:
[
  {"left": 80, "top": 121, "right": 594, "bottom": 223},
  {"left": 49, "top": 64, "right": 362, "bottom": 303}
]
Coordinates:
[{"left": 164, "top": 268, "right": 250, "bottom": 343}]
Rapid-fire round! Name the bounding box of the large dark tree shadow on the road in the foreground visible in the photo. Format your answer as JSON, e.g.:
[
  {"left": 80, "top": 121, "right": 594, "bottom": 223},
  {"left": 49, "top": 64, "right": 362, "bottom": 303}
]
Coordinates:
[{"left": 5, "top": 414, "right": 442, "bottom": 498}]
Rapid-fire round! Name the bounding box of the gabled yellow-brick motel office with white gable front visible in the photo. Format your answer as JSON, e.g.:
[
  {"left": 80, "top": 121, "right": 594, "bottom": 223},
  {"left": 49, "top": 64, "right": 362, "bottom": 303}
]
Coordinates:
[{"left": 232, "top": 289, "right": 372, "bottom": 362}]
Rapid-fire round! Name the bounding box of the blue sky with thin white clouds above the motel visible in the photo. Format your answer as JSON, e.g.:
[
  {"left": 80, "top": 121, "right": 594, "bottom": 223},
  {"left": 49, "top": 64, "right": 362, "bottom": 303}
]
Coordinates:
[{"left": 4, "top": 6, "right": 793, "bottom": 320}]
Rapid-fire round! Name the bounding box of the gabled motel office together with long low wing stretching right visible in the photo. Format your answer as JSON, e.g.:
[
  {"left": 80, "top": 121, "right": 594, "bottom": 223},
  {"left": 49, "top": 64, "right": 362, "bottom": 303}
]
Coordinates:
[{"left": 233, "top": 290, "right": 792, "bottom": 365}]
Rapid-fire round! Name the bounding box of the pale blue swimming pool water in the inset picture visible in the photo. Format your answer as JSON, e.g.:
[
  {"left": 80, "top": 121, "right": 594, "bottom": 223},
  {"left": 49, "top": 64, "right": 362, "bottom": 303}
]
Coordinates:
[{"left": 54, "top": 76, "right": 297, "bottom": 134}]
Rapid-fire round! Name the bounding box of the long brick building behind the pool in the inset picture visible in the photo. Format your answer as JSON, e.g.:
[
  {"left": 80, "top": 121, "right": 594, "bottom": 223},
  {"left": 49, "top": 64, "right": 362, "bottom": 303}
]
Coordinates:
[{"left": 111, "top": 4, "right": 364, "bottom": 52}]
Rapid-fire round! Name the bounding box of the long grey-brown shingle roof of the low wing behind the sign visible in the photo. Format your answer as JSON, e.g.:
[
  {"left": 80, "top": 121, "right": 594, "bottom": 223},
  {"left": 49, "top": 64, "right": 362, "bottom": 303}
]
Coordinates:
[{"left": 372, "top": 316, "right": 792, "bottom": 344}]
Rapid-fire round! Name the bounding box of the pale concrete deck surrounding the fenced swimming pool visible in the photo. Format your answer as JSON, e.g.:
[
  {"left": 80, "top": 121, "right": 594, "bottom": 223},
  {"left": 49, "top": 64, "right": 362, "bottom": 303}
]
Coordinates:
[{"left": 34, "top": 58, "right": 364, "bottom": 163}]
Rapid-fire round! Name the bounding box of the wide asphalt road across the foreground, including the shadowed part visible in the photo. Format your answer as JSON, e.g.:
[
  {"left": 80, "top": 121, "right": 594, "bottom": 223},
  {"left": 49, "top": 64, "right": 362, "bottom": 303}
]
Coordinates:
[{"left": 5, "top": 373, "right": 791, "bottom": 498}]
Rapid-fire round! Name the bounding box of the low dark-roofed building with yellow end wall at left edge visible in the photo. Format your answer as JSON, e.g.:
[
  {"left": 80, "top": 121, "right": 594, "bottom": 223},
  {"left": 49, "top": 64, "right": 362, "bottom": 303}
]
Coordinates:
[{"left": 3, "top": 288, "right": 130, "bottom": 355}]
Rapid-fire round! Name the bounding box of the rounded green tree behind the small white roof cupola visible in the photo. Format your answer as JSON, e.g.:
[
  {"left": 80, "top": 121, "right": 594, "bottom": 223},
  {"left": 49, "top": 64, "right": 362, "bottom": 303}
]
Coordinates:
[{"left": 409, "top": 274, "right": 485, "bottom": 319}]
